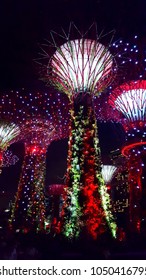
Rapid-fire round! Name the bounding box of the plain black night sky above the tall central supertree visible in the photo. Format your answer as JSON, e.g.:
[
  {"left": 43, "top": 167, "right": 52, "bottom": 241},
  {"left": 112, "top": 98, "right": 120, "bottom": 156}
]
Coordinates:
[{"left": 0, "top": 0, "right": 146, "bottom": 89}]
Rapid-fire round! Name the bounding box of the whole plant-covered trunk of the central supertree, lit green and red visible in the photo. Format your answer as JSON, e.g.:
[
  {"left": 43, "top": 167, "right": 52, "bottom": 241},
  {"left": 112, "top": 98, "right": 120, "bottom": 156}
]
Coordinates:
[{"left": 64, "top": 95, "right": 105, "bottom": 238}]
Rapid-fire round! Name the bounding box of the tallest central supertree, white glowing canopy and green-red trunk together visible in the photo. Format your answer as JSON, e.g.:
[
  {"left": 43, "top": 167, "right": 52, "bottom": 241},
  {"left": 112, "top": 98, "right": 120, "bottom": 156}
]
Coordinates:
[{"left": 38, "top": 25, "right": 116, "bottom": 238}]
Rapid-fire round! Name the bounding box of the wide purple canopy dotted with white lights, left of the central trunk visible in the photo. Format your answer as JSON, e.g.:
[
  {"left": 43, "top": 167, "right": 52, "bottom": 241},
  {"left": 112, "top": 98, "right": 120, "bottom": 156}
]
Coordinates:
[{"left": 0, "top": 89, "right": 70, "bottom": 143}]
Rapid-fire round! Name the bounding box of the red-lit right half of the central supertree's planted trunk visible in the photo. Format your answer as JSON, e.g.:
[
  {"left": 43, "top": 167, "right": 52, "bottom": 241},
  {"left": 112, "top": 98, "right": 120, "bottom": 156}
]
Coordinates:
[{"left": 82, "top": 109, "right": 105, "bottom": 239}]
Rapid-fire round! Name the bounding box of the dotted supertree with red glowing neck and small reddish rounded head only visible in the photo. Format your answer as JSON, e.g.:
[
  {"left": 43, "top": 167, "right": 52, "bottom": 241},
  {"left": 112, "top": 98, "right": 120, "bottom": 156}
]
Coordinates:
[{"left": 13, "top": 118, "right": 56, "bottom": 231}]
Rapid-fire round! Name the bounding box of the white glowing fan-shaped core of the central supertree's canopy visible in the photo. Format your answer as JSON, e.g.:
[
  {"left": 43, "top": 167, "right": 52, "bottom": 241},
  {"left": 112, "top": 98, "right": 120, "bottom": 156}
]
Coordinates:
[{"left": 51, "top": 39, "right": 113, "bottom": 92}]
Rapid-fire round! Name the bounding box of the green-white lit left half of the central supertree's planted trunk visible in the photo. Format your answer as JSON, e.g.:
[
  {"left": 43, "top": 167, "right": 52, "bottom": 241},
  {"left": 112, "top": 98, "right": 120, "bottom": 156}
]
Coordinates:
[{"left": 62, "top": 103, "right": 83, "bottom": 238}]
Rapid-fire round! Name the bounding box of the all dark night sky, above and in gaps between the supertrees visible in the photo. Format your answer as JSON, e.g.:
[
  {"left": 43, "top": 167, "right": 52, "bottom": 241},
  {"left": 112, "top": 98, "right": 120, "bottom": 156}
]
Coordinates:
[{"left": 0, "top": 0, "right": 146, "bottom": 208}]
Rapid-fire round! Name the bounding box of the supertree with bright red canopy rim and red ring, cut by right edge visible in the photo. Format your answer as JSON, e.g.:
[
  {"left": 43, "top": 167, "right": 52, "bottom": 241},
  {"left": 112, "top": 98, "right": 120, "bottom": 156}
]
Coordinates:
[{"left": 109, "top": 80, "right": 146, "bottom": 231}]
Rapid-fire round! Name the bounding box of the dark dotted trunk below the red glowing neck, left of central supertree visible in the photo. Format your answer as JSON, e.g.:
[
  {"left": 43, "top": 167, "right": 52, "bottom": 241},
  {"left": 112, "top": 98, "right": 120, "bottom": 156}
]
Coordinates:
[{"left": 10, "top": 147, "right": 46, "bottom": 232}]
